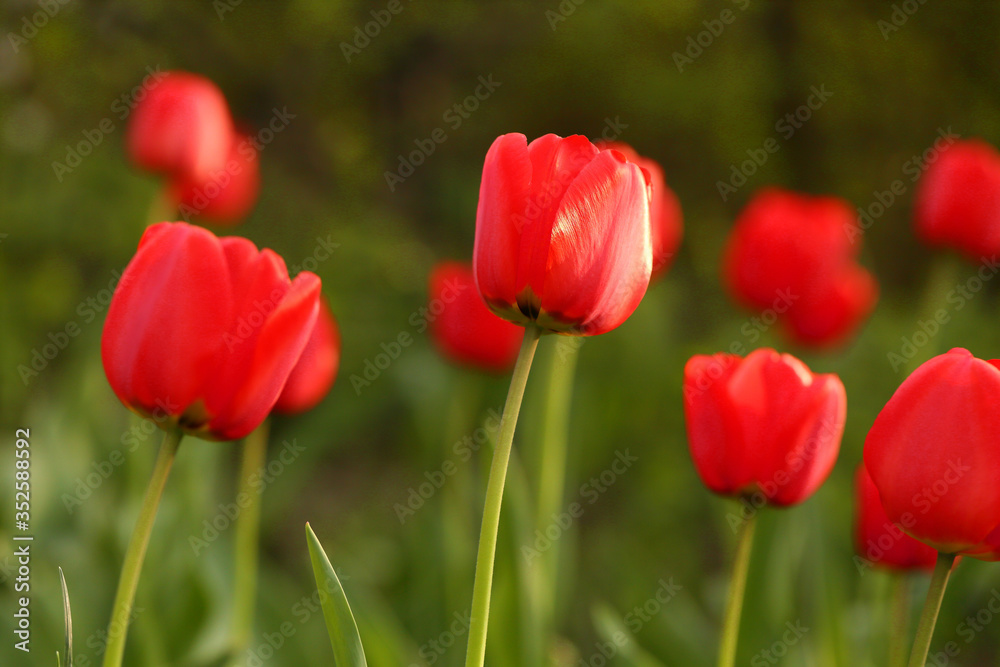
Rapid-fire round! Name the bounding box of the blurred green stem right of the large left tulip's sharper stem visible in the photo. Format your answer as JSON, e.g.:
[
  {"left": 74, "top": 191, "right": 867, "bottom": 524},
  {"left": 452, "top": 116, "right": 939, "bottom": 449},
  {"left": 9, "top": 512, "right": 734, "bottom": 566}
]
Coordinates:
[{"left": 231, "top": 420, "right": 271, "bottom": 664}]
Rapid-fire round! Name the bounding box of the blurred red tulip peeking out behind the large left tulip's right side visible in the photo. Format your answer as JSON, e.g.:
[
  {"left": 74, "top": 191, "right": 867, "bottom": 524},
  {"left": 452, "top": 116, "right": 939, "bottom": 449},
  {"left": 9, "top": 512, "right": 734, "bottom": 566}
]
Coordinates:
[{"left": 274, "top": 298, "right": 340, "bottom": 414}]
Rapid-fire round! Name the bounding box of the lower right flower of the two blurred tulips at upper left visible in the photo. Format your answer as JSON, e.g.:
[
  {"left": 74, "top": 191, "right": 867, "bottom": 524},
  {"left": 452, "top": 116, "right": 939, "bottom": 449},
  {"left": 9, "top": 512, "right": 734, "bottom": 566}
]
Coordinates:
[{"left": 170, "top": 134, "right": 260, "bottom": 224}]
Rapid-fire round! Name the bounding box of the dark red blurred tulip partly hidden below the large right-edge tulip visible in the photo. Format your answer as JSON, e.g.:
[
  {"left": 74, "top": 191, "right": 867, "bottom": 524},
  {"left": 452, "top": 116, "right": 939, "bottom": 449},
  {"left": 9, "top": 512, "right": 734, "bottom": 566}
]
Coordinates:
[{"left": 854, "top": 463, "right": 937, "bottom": 570}]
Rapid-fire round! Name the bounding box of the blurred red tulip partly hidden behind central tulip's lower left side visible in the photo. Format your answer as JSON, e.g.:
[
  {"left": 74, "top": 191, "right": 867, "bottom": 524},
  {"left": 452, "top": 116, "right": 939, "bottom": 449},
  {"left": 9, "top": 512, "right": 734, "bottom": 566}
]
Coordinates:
[{"left": 428, "top": 262, "right": 524, "bottom": 373}]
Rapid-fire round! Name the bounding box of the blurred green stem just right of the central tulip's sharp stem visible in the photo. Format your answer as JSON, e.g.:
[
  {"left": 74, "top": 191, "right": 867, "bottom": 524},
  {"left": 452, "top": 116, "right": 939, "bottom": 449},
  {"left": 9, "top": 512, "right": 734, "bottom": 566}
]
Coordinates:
[{"left": 535, "top": 336, "right": 583, "bottom": 648}]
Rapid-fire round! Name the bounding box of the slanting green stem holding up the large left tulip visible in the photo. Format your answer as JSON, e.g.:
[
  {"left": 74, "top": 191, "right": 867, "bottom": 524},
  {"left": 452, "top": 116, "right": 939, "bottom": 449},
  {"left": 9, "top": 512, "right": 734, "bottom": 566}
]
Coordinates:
[{"left": 103, "top": 429, "right": 184, "bottom": 667}]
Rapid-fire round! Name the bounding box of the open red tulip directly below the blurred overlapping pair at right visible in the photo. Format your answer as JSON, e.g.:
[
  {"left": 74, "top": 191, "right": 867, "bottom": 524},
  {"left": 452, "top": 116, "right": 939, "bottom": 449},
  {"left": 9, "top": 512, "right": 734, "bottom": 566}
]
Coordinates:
[{"left": 684, "top": 348, "right": 847, "bottom": 506}]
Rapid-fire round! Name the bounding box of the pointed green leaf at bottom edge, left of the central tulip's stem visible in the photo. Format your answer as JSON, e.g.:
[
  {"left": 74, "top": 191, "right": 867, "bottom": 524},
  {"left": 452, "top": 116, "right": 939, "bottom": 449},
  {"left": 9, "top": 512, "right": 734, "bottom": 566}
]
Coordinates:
[{"left": 306, "top": 523, "right": 368, "bottom": 667}]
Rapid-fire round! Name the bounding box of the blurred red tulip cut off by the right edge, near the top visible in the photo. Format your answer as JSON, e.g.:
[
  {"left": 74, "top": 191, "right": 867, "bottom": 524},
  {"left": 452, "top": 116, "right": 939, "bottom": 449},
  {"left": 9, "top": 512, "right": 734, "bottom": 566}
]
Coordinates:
[{"left": 916, "top": 139, "right": 1000, "bottom": 262}]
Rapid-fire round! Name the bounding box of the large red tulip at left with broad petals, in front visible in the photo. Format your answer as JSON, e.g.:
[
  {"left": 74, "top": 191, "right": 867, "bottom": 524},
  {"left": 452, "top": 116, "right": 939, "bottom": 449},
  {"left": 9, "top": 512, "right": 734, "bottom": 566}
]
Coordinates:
[{"left": 101, "top": 222, "right": 320, "bottom": 440}]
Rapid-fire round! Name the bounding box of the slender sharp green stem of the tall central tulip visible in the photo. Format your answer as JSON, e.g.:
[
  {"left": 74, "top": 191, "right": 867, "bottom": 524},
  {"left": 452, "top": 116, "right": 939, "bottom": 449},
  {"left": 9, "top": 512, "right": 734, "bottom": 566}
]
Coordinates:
[{"left": 465, "top": 325, "right": 541, "bottom": 667}]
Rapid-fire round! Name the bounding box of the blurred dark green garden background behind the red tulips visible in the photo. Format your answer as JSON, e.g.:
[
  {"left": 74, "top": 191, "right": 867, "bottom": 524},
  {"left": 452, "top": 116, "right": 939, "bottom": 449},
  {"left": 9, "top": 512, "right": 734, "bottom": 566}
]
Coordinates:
[{"left": 0, "top": 0, "right": 1000, "bottom": 667}]
